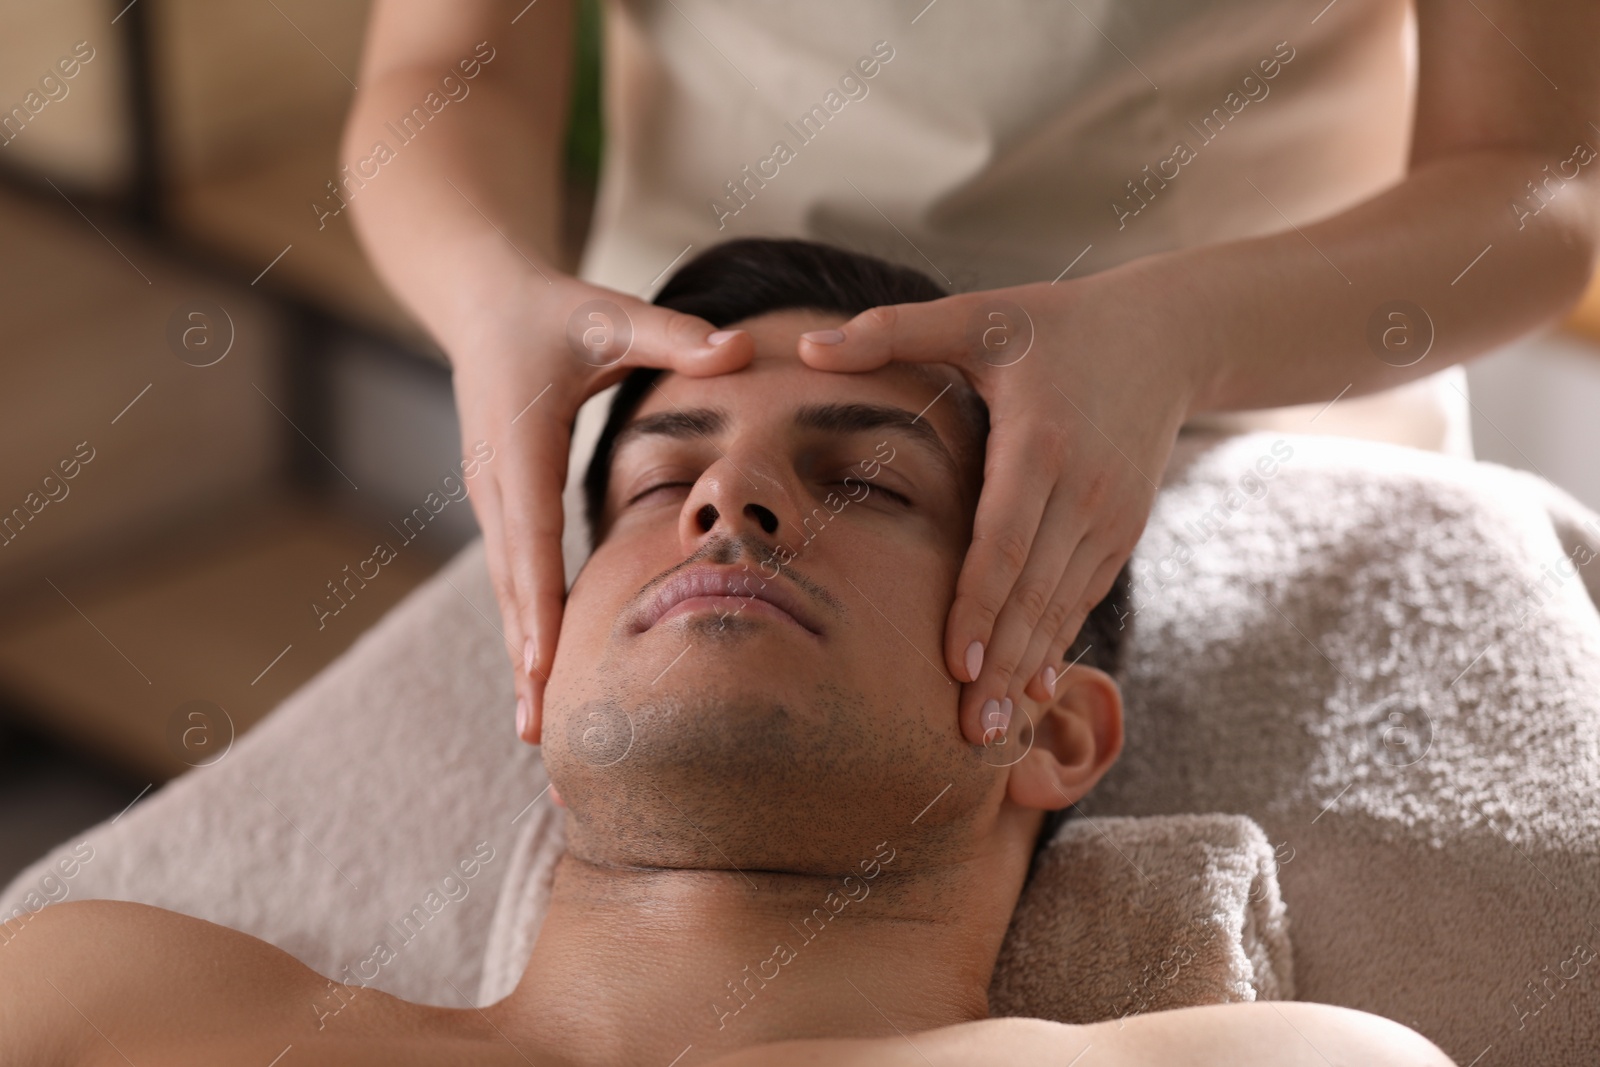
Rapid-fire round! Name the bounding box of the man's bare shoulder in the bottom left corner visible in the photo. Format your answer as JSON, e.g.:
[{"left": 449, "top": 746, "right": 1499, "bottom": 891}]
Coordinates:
[{"left": 0, "top": 901, "right": 499, "bottom": 1067}]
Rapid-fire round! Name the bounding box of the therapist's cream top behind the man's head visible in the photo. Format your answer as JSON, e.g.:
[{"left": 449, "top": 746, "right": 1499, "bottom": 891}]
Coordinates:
[{"left": 566, "top": 0, "right": 1470, "bottom": 575}]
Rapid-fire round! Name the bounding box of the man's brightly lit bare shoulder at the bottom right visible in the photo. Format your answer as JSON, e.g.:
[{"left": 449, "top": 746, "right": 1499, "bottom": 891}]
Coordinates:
[{"left": 707, "top": 1001, "right": 1456, "bottom": 1067}]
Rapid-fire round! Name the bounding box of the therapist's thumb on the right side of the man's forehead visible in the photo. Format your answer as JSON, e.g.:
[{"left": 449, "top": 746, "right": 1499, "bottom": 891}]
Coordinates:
[{"left": 798, "top": 293, "right": 982, "bottom": 371}]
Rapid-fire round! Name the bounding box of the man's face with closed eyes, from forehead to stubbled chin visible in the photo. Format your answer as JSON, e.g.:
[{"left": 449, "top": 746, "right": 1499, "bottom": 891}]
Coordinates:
[{"left": 542, "top": 310, "right": 1005, "bottom": 872}]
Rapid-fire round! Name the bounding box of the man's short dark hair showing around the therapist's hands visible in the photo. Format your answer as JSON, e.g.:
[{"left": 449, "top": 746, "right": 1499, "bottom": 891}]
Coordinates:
[{"left": 584, "top": 237, "right": 1131, "bottom": 872}]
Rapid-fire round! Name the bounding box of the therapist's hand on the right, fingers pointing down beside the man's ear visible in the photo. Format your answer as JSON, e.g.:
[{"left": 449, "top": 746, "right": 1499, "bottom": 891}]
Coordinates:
[{"left": 798, "top": 272, "right": 1200, "bottom": 744}]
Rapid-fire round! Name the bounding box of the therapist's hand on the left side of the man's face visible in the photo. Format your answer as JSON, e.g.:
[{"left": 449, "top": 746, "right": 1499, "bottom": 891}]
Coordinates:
[{"left": 450, "top": 275, "right": 754, "bottom": 744}]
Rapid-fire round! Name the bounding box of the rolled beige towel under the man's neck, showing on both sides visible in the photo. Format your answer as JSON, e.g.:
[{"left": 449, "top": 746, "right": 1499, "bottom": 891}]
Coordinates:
[{"left": 477, "top": 806, "right": 1294, "bottom": 1022}]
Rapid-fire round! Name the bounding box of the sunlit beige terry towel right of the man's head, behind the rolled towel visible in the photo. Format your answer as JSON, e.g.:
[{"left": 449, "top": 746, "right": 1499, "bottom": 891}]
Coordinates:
[{"left": 1083, "top": 434, "right": 1600, "bottom": 1067}]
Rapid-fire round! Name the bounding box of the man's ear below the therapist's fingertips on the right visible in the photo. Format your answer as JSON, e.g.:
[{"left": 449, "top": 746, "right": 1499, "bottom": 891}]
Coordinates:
[{"left": 1006, "top": 664, "right": 1122, "bottom": 811}]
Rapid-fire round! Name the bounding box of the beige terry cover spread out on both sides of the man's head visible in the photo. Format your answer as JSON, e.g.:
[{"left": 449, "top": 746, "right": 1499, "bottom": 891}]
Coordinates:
[{"left": 9, "top": 434, "right": 1600, "bottom": 1067}]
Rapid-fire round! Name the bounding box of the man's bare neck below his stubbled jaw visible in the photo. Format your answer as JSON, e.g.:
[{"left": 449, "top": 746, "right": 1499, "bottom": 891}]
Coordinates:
[{"left": 496, "top": 843, "right": 1016, "bottom": 1067}]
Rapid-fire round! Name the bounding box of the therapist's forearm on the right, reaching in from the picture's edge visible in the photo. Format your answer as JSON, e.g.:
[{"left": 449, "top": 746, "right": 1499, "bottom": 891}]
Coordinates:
[{"left": 1113, "top": 152, "right": 1600, "bottom": 414}]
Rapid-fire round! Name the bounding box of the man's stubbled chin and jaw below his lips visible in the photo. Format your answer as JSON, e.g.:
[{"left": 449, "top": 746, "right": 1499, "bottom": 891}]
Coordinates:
[{"left": 542, "top": 684, "right": 995, "bottom": 870}]
